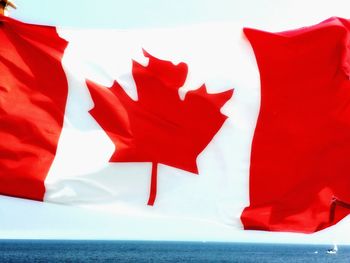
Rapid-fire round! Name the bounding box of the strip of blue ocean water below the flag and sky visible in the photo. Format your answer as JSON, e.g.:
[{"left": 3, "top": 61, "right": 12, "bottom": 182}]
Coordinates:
[{"left": 0, "top": 240, "right": 350, "bottom": 263}]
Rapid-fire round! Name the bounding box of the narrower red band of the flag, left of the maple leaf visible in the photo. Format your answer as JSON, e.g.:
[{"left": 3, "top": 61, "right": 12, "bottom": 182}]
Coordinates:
[{"left": 0, "top": 16, "right": 68, "bottom": 200}]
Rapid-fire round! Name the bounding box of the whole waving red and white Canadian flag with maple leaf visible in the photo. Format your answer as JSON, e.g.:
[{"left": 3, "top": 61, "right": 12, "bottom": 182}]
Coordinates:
[{"left": 0, "top": 16, "right": 350, "bottom": 233}]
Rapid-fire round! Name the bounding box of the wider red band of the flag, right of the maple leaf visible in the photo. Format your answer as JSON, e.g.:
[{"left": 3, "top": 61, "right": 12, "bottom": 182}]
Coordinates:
[{"left": 241, "top": 18, "right": 350, "bottom": 233}]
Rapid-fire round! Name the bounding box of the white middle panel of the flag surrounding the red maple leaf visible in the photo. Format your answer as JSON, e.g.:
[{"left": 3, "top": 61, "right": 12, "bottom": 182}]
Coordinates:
[{"left": 44, "top": 24, "right": 260, "bottom": 227}]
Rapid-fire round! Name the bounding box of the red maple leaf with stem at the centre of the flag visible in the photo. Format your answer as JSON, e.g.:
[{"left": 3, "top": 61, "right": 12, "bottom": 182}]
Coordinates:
[{"left": 87, "top": 52, "right": 233, "bottom": 205}]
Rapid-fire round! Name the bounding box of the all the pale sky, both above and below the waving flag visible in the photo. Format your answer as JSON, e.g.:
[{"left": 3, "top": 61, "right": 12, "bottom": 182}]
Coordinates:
[{"left": 0, "top": 0, "right": 350, "bottom": 243}]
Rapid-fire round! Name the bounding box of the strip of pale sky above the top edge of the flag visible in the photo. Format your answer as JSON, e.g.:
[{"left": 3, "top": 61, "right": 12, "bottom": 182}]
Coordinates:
[{"left": 12, "top": 0, "right": 349, "bottom": 30}]
